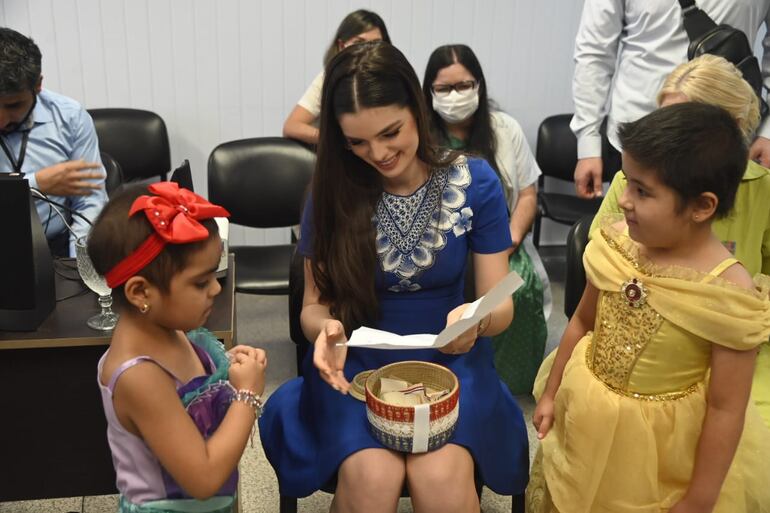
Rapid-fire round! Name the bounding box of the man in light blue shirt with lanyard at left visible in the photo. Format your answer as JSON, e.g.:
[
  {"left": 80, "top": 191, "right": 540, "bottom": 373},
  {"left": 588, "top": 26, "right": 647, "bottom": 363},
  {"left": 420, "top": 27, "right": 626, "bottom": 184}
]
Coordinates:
[{"left": 0, "top": 28, "right": 107, "bottom": 256}]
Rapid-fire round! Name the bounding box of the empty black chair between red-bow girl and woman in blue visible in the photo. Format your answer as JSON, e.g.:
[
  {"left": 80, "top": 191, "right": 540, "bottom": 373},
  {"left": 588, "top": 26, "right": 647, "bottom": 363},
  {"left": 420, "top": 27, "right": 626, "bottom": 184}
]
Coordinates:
[{"left": 208, "top": 137, "right": 315, "bottom": 295}]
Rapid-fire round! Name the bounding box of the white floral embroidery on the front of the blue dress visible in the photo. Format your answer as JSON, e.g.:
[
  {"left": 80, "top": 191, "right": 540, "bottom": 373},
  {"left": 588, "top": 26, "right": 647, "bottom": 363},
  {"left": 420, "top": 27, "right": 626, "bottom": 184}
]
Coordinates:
[{"left": 374, "top": 157, "right": 473, "bottom": 292}]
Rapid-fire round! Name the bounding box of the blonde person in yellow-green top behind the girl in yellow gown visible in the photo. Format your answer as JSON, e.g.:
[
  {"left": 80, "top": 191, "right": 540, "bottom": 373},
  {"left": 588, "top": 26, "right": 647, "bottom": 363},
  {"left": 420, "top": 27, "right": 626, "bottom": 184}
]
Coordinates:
[{"left": 590, "top": 55, "right": 770, "bottom": 426}]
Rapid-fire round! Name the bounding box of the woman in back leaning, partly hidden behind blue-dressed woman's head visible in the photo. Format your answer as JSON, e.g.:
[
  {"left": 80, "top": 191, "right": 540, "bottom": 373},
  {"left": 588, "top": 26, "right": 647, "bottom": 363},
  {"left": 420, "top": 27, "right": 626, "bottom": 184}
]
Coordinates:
[{"left": 283, "top": 9, "right": 390, "bottom": 144}]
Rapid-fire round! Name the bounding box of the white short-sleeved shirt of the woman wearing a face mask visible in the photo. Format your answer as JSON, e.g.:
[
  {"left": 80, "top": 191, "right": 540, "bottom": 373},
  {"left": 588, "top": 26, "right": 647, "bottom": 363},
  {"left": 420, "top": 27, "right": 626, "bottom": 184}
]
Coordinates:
[{"left": 489, "top": 111, "right": 542, "bottom": 214}]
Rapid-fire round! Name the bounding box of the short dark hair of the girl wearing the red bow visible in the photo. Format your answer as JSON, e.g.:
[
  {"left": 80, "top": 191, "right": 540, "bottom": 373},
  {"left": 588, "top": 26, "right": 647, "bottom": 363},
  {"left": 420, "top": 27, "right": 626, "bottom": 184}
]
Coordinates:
[{"left": 88, "top": 185, "right": 219, "bottom": 305}]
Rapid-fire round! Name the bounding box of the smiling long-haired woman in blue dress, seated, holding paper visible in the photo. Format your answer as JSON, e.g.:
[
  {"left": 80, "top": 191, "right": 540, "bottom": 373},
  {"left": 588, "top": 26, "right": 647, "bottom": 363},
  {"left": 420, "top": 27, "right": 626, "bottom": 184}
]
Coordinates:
[{"left": 259, "top": 42, "right": 529, "bottom": 513}]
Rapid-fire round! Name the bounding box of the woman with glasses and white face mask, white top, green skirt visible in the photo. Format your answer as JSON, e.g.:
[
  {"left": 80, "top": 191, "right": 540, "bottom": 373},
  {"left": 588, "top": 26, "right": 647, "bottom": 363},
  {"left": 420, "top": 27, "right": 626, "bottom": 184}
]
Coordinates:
[{"left": 422, "top": 45, "right": 551, "bottom": 394}]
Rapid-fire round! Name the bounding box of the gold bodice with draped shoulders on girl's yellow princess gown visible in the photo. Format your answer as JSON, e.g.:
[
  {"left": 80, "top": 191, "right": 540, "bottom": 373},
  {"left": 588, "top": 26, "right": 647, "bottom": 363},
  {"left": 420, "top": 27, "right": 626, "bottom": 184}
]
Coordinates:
[{"left": 583, "top": 218, "right": 770, "bottom": 400}]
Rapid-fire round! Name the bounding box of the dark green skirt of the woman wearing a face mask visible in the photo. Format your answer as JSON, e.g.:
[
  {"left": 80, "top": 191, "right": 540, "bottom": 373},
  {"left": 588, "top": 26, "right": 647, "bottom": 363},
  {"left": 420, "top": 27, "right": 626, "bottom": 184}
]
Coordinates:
[{"left": 492, "top": 246, "right": 548, "bottom": 395}]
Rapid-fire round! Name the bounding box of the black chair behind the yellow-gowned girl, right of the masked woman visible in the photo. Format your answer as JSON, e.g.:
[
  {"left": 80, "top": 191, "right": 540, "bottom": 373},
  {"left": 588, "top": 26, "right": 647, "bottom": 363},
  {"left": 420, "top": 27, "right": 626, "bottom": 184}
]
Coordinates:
[{"left": 532, "top": 114, "right": 602, "bottom": 247}]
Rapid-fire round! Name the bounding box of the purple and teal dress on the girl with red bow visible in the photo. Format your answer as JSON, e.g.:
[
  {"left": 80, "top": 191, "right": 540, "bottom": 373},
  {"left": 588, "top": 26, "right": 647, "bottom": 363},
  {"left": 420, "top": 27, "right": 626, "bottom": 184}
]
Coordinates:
[{"left": 97, "top": 328, "right": 238, "bottom": 513}]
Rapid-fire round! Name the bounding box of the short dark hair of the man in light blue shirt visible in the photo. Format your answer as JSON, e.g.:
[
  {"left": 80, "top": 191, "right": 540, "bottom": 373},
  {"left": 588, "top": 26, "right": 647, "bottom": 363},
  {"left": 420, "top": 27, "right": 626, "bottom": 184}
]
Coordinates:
[{"left": 0, "top": 27, "right": 42, "bottom": 96}]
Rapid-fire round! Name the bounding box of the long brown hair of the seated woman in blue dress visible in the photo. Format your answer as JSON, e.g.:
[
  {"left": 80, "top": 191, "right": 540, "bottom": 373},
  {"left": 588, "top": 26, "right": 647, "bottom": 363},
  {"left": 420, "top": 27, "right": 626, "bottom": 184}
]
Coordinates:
[{"left": 311, "top": 41, "right": 455, "bottom": 331}]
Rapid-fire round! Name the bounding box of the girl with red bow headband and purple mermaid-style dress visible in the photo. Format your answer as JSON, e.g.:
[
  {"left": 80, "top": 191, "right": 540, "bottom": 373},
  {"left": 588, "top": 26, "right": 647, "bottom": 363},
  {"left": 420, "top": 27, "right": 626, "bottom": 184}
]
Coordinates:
[{"left": 88, "top": 182, "right": 267, "bottom": 513}]
